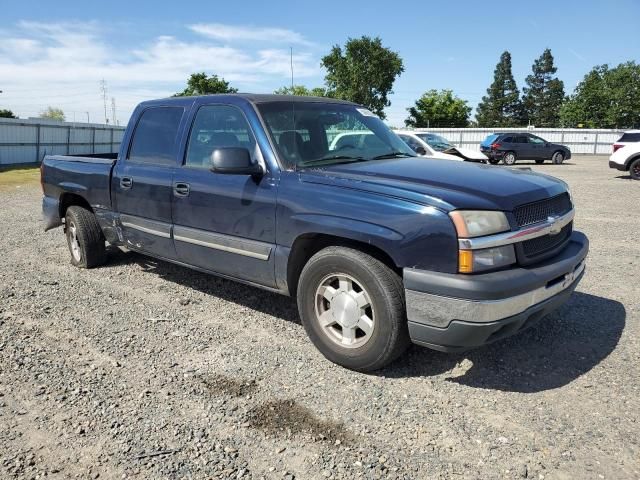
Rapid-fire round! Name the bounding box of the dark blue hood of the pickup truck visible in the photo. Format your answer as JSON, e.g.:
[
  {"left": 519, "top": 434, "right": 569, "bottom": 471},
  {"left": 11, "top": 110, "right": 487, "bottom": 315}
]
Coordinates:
[{"left": 299, "top": 157, "right": 567, "bottom": 211}]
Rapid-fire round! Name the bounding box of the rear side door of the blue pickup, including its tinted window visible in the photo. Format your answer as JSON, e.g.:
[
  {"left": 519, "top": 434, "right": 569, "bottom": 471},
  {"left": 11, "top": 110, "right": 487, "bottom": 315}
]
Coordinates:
[{"left": 112, "top": 106, "right": 184, "bottom": 259}]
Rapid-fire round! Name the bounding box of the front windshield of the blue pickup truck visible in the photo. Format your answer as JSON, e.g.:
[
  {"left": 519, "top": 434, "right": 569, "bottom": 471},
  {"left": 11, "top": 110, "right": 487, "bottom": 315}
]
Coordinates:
[{"left": 257, "top": 101, "right": 416, "bottom": 168}]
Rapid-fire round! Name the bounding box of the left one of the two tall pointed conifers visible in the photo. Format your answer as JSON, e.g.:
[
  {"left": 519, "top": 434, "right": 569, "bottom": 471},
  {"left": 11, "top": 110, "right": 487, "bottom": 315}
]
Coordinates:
[{"left": 476, "top": 51, "right": 524, "bottom": 127}]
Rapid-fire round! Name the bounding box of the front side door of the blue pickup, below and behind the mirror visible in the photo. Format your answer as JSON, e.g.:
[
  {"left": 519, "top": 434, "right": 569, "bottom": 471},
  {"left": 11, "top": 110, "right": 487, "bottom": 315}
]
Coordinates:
[{"left": 172, "top": 105, "right": 276, "bottom": 287}]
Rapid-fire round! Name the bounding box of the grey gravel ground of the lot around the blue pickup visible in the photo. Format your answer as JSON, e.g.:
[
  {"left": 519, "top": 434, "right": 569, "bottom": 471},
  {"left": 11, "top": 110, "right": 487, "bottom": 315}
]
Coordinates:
[{"left": 0, "top": 157, "right": 640, "bottom": 479}]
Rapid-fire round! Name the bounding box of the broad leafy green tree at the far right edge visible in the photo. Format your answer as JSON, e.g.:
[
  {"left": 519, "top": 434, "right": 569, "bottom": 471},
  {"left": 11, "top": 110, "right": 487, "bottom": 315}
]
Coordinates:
[{"left": 560, "top": 62, "right": 640, "bottom": 128}]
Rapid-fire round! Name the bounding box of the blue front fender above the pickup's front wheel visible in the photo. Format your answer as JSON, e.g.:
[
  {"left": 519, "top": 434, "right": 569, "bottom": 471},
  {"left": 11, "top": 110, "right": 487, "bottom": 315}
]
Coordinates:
[{"left": 276, "top": 174, "right": 458, "bottom": 280}]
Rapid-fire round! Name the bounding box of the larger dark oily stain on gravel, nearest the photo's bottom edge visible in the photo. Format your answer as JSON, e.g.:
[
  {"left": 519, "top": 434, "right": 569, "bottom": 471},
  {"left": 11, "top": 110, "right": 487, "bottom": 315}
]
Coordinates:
[{"left": 249, "top": 400, "right": 355, "bottom": 445}]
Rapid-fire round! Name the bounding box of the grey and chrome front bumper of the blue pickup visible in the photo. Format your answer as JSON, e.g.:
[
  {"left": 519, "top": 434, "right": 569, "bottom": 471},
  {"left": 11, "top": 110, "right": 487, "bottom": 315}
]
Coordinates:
[{"left": 404, "top": 232, "right": 589, "bottom": 351}]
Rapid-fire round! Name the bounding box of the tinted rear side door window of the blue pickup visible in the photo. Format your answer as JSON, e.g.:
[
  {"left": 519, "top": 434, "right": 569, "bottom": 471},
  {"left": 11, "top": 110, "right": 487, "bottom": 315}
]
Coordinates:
[{"left": 127, "top": 107, "right": 184, "bottom": 165}]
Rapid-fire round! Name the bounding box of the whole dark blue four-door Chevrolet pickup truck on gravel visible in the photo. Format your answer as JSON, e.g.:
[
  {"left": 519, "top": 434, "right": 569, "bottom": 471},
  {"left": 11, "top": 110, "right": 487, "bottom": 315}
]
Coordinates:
[{"left": 41, "top": 94, "right": 589, "bottom": 371}]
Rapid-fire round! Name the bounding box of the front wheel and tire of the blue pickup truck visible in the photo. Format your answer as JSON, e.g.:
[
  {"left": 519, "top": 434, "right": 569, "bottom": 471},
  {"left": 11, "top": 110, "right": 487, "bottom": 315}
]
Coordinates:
[{"left": 297, "top": 247, "right": 410, "bottom": 372}]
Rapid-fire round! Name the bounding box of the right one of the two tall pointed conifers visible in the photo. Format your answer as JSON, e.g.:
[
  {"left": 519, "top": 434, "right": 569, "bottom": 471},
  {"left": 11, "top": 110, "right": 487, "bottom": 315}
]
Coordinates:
[{"left": 522, "top": 48, "right": 564, "bottom": 127}]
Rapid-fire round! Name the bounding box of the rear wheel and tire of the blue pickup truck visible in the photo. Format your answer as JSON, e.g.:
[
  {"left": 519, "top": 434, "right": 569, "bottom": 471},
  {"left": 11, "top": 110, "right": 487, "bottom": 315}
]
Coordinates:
[{"left": 65, "top": 206, "right": 107, "bottom": 268}]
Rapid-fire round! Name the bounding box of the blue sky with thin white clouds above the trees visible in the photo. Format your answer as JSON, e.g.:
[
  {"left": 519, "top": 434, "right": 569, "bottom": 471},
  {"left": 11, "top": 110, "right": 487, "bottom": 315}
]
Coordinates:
[{"left": 0, "top": 0, "right": 640, "bottom": 126}]
